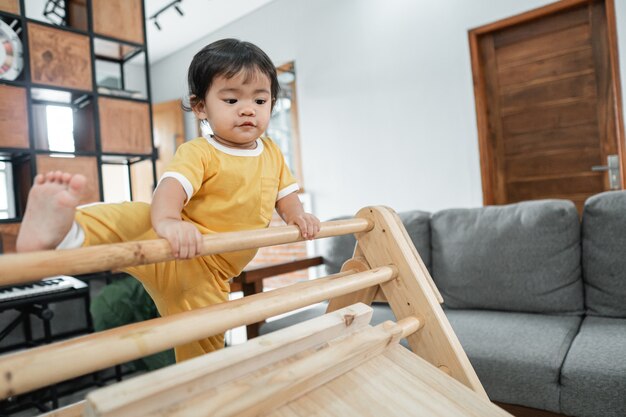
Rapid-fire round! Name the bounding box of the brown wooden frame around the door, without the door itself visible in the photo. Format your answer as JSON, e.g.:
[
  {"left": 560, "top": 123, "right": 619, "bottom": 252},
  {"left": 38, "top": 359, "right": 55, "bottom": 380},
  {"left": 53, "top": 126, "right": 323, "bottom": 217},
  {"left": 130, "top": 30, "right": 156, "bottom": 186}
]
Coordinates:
[{"left": 468, "top": 0, "right": 626, "bottom": 205}]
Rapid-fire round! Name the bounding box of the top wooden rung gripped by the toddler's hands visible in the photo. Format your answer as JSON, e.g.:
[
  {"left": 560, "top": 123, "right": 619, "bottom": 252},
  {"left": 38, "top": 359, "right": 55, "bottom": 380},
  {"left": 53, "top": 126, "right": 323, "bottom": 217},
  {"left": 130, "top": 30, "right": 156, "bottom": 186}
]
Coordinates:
[{"left": 0, "top": 219, "right": 374, "bottom": 286}]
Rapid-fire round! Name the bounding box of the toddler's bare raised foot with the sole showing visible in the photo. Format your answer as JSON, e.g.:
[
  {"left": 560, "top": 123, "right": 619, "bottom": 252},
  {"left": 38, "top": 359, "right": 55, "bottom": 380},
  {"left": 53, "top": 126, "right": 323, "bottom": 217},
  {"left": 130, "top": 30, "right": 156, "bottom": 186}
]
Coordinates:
[{"left": 16, "top": 171, "right": 87, "bottom": 252}]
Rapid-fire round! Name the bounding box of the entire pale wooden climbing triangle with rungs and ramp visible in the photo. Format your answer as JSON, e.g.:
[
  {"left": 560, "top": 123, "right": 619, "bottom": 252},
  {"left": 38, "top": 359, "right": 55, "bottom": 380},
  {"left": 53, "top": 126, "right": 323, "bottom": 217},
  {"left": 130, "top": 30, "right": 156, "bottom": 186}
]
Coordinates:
[{"left": 0, "top": 207, "right": 509, "bottom": 417}]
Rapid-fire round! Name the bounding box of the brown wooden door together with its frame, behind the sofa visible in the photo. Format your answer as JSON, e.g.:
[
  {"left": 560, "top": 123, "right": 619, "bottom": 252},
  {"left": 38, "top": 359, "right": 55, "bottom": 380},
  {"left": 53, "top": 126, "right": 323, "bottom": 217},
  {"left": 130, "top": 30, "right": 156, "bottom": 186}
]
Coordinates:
[{"left": 469, "top": 0, "right": 625, "bottom": 210}]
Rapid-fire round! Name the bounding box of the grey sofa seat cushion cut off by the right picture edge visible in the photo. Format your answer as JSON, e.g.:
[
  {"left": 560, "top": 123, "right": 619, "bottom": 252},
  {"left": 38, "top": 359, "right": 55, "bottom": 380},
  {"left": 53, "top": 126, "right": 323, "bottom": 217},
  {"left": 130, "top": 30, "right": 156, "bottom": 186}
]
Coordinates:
[{"left": 561, "top": 316, "right": 626, "bottom": 417}]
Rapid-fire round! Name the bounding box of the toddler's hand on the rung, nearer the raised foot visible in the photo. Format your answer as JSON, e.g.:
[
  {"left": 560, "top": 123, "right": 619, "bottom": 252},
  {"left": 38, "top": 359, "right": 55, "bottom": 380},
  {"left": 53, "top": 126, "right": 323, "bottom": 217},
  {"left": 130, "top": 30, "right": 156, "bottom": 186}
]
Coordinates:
[{"left": 154, "top": 219, "right": 202, "bottom": 259}]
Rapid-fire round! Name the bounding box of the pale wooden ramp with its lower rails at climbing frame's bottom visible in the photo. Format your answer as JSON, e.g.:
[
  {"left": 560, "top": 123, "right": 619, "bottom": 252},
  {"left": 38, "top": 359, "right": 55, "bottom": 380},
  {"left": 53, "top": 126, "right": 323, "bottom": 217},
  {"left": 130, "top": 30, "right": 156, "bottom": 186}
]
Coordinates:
[{"left": 85, "top": 303, "right": 508, "bottom": 417}]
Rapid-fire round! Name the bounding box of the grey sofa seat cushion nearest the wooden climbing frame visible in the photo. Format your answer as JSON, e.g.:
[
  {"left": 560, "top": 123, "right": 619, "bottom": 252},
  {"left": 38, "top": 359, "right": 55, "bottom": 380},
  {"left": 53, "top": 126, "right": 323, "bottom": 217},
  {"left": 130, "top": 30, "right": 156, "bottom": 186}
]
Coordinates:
[{"left": 446, "top": 310, "right": 581, "bottom": 412}]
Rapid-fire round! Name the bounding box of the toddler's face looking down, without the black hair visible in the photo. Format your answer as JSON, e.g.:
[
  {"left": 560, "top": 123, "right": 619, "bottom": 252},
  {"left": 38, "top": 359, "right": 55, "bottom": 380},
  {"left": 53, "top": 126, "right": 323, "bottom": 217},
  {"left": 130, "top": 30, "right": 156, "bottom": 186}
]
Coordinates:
[{"left": 197, "top": 70, "right": 272, "bottom": 148}]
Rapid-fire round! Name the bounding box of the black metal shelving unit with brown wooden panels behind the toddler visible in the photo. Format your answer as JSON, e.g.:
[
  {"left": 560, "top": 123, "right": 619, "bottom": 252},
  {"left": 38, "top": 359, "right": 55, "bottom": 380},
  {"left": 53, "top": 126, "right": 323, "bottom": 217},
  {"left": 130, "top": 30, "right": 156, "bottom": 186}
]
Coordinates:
[{"left": 0, "top": 0, "right": 157, "bottom": 252}]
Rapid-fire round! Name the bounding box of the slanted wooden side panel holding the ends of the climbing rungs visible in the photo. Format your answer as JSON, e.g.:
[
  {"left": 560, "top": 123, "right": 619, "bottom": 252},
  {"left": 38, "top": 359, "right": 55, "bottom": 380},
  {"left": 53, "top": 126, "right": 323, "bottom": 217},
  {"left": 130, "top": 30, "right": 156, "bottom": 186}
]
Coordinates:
[{"left": 348, "top": 206, "right": 488, "bottom": 398}]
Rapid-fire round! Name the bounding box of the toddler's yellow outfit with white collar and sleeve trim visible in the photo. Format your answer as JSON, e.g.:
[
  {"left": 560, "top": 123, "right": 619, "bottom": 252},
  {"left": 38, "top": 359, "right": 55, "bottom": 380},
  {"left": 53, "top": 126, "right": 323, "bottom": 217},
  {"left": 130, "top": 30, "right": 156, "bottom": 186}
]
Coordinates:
[{"left": 76, "top": 137, "right": 298, "bottom": 362}]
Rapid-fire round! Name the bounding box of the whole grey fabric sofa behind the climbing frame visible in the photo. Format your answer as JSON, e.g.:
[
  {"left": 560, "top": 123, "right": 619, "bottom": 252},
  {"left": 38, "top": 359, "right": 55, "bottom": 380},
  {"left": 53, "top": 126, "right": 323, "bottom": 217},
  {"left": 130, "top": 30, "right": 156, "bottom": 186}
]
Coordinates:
[{"left": 261, "top": 191, "right": 626, "bottom": 417}]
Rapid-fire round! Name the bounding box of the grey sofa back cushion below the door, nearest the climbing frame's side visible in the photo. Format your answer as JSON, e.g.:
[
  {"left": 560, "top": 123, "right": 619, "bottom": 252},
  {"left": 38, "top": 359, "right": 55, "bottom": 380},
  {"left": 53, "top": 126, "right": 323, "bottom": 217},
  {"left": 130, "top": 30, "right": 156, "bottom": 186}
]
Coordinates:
[{"left": 431, "top": 200, "right": 583, "bottom": 314}]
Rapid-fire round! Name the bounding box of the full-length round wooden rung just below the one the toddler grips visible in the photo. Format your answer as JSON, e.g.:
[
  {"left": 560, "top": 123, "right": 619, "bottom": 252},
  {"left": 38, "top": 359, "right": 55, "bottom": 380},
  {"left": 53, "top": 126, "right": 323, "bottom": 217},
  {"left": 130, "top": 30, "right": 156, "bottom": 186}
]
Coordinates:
[{"left": 0, "top": 266, "right": 397, "bottom": 398}]
